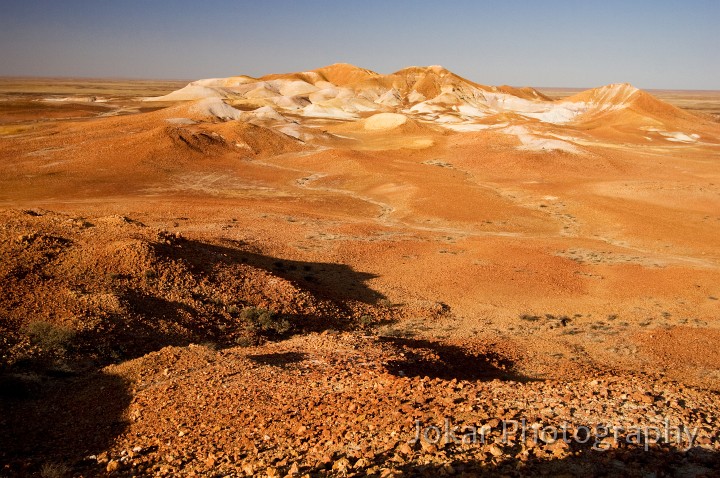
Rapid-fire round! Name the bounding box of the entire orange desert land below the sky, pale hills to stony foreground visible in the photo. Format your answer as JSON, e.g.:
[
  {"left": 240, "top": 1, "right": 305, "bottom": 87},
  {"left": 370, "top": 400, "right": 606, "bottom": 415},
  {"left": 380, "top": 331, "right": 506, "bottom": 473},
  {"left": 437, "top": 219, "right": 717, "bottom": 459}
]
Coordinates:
[{"left": 0, "top": 64, "right": 720, "bottom": 477}]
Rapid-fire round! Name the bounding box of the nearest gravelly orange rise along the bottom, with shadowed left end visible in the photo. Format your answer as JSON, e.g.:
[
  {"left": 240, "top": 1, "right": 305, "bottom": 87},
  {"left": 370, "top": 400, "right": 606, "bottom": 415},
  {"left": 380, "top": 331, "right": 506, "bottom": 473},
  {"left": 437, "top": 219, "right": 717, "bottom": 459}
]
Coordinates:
[{"left": 3, "top": 332, "right": 720, "bottom": 477}]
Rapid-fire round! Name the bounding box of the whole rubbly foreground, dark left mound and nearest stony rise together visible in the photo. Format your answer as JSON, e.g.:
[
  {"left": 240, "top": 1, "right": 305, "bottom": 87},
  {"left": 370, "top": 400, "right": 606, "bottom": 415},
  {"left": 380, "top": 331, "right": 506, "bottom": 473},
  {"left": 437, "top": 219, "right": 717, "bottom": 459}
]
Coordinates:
[{"left": 0, "top": 211, "right": 720, "bottom": 477}]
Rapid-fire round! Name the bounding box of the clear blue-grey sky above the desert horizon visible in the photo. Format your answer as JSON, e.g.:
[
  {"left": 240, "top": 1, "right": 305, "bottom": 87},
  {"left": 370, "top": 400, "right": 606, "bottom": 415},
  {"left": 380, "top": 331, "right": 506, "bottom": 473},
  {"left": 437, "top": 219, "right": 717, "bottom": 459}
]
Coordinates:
[{"left": 0, "top": 0, "right": 720, "bottom": 90}]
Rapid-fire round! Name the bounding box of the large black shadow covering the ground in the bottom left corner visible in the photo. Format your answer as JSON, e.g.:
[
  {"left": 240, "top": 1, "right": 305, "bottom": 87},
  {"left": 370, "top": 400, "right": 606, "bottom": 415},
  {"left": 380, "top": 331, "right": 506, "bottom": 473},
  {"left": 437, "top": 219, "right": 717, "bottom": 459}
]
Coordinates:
[{"left": 0, "top": 371, "right": 132, "bottom": 476}]
